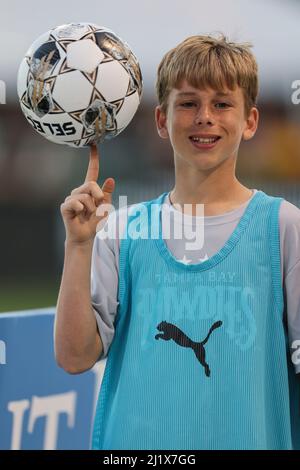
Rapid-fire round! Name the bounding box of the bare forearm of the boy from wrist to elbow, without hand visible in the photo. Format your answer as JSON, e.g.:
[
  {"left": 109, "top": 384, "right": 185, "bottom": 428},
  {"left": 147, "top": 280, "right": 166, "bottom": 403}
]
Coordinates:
[{"left": 55, "top": 241, "right": 102, "bottom": 374}]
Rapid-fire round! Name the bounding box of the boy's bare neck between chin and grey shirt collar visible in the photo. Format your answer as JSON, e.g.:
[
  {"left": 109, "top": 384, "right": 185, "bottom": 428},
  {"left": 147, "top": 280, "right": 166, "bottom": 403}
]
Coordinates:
[{"left": 170, "top": 176, "right": 253, "bottom": 216}]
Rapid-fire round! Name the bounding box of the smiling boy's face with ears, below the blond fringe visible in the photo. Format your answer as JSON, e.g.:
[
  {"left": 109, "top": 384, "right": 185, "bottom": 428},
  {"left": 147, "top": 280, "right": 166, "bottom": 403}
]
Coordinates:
[{"left": 155, "top": 81, "right": 258, "bottom": 170}]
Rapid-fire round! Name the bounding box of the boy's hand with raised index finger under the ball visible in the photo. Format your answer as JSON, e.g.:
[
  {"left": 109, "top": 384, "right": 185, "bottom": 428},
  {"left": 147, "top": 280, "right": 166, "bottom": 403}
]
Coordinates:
[{"left": 60, "top": 145, "right": 115, "bottom": 244}]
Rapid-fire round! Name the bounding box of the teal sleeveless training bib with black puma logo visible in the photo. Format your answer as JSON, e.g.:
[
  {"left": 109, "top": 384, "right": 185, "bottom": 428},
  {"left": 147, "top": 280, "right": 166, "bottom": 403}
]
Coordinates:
[{"left": 92, "top": 191, "right": 300, "bottom": 450}]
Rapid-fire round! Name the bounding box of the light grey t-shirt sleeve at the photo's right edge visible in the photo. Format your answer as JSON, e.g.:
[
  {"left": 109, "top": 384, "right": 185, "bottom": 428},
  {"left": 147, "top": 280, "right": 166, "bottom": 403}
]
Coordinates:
[{"left": 279, "top": 201, "right": 300, "bottom": 374}]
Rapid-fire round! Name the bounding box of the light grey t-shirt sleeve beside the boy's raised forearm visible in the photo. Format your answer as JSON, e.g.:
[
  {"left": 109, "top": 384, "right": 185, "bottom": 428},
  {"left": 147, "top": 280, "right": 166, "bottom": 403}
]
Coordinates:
[{"left": 91, "top": 212, "right": 119, "bottom": 360}]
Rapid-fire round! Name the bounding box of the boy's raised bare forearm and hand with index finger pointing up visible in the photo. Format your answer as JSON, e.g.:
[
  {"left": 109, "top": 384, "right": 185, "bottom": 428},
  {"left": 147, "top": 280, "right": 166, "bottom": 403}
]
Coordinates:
[{"left": 54, "top": 146, "right": 114, "bottom": 373}]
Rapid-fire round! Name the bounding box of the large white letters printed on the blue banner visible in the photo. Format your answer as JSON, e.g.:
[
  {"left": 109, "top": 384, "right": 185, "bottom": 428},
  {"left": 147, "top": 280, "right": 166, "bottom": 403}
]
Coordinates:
[{"left": 8, "top": 391, "right": 76, "bottom": 450}]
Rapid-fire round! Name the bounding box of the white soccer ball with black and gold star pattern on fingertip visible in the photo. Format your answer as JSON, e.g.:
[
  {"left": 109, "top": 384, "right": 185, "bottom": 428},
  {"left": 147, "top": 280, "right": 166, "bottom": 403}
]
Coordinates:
[{"left": 18, "top": 23, "right": 143, "bottom": 147}]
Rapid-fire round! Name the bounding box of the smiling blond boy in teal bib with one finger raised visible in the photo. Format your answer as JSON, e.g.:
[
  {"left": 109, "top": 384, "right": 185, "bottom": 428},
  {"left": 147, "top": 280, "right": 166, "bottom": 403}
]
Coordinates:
[{"left": 55, "top": 36, "right": 300, "bottom": 449}]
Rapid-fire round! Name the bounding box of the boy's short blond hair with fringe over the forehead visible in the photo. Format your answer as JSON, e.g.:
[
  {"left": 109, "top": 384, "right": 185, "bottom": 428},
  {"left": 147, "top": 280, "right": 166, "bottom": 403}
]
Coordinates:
[{"left": 156, "top": 33, "right": 258, "bottom": 116}]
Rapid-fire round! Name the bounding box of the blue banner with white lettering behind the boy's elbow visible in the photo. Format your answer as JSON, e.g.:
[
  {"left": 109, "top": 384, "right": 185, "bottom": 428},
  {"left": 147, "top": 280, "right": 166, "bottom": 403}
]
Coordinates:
[{"left": 0, "top": 308, "right": 105, "bottom": 449}]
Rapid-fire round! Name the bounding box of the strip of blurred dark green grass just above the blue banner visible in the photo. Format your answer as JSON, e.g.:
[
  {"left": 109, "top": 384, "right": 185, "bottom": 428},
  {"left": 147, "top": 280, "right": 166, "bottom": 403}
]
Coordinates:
[{"left": 0, "top": 279, "right": 60, "bottom": 313}]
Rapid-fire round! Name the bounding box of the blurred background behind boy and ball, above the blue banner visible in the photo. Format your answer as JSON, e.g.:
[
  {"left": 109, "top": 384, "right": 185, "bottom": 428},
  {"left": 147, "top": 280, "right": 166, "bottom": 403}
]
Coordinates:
[{"left": 0, "top": 0, "right": 300, "bottom": 312}]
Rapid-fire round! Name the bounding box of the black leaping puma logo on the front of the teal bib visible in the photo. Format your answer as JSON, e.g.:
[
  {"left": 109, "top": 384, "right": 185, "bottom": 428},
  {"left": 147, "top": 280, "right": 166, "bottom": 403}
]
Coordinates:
[{"left": 155, "top": 321, "right": 222, "bottom": 377}]
